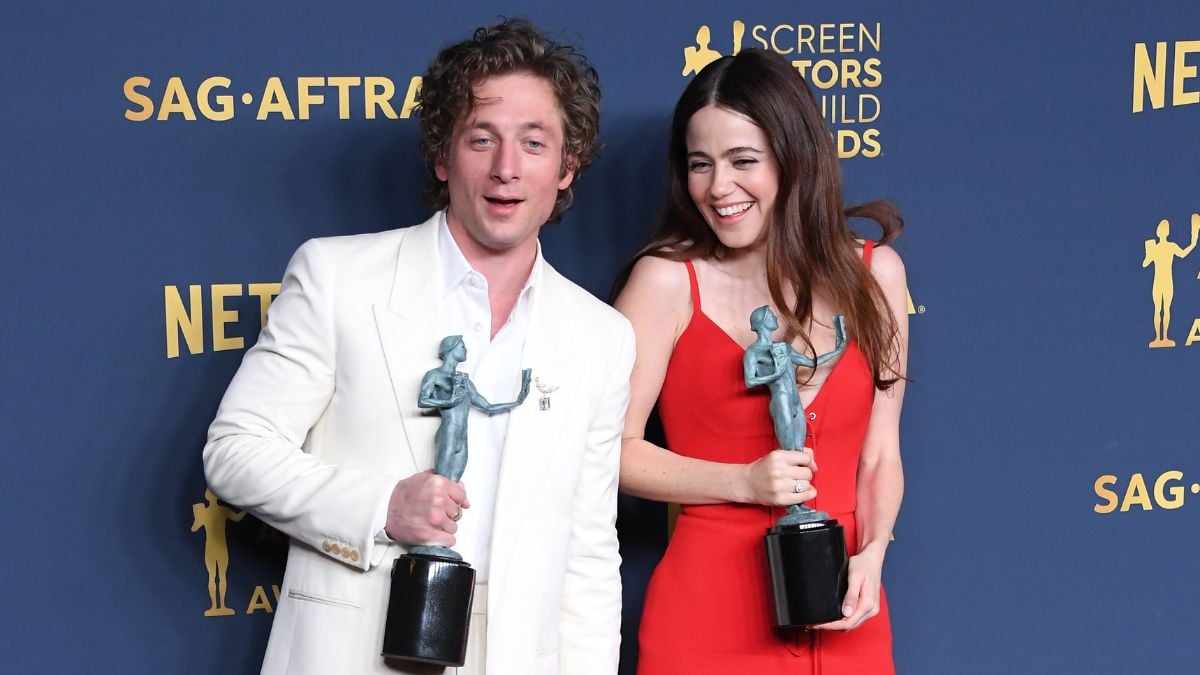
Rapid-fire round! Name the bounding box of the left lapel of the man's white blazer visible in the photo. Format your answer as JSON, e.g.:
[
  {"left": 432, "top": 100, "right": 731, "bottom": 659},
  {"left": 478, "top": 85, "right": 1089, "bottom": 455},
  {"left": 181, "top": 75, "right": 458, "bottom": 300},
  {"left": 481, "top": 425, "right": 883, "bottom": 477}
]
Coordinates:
[{"left": 374, "top": 215, "right": 445, "bottom": 471}]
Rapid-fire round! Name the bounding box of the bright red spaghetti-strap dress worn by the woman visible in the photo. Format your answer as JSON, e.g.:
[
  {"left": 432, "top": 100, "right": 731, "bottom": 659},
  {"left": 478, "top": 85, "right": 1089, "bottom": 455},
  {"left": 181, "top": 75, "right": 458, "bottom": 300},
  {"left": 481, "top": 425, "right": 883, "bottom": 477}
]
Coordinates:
[{"left": 637, "top": 243, "right": 895, "bottom": 675}]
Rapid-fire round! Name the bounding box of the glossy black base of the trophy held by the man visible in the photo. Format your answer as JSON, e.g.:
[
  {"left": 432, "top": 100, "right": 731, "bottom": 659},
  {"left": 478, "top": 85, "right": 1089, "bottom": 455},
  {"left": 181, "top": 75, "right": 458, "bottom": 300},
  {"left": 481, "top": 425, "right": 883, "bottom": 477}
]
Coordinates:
[{"left": 383, "top": 554, "right": 475, "bottom": 667}]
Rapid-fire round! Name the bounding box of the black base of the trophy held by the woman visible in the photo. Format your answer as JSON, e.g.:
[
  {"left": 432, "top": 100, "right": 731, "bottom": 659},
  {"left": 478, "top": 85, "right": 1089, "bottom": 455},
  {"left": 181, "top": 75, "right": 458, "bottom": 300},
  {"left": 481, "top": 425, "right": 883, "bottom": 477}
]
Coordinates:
[{"left": 763, "top": 520, "right": 848, "bottom": 628}]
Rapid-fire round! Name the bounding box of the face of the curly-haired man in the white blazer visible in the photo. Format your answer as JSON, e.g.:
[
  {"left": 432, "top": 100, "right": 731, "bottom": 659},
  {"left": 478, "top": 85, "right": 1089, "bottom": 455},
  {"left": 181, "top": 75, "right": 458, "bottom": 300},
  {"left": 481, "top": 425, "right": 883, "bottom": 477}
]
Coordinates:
[{"left": 434, "top": 72, "right": 575, "bottom": 259}]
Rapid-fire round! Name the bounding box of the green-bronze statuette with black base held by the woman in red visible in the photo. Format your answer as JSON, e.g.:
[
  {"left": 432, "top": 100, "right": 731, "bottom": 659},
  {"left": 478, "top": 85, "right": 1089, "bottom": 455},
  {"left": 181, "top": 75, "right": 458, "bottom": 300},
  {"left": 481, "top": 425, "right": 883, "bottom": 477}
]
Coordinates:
[{"left": 743, "top": 306, "right": 847, "bottom": 628}]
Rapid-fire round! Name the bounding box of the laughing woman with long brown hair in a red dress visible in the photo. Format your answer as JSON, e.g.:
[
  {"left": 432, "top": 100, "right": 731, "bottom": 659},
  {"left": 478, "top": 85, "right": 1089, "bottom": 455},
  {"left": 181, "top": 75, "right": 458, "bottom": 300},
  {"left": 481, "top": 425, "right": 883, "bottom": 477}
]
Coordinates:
[{"left": 617, "top": 49, "right": 907, "bottom": 675}]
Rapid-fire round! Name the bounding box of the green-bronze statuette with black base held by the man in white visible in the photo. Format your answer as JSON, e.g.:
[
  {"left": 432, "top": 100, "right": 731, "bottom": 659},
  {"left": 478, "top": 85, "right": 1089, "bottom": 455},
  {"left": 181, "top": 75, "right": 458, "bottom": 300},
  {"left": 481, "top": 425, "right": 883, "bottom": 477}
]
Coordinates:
[{"left": 383, "top": 335, "right": 529, "bottom": 667}]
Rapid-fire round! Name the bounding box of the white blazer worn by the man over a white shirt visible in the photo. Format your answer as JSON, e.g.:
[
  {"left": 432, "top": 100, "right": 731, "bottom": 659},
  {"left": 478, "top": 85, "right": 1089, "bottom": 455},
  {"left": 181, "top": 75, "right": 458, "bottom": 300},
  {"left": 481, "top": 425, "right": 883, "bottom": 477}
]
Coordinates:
[{"left": 204, "top": 216, "right": 635, "bottom": 675}]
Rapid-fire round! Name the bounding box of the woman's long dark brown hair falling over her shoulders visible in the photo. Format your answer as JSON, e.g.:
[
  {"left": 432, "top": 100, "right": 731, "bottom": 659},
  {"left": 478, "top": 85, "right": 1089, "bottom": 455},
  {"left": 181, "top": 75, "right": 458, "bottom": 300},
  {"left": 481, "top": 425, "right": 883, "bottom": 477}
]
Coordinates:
[{"left": 617, "top": 49, "right": 904, "bottom": 389}]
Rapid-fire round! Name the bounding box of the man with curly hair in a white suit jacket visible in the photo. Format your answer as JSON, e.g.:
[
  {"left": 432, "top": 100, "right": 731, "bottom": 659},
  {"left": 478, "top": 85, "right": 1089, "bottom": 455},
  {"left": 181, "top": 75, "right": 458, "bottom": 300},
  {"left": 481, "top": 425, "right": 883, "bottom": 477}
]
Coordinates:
[{"left": 204, "top": 19, "right": 634, "bottom": 675}]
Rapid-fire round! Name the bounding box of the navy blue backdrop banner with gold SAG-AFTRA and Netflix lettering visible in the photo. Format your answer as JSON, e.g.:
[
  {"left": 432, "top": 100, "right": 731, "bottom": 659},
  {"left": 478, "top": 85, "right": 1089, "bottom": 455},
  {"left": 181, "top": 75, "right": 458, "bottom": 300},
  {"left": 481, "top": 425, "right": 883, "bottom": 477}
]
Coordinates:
[{"left": 0, "top": 0, "right": 1200, "bottom": 674}]
